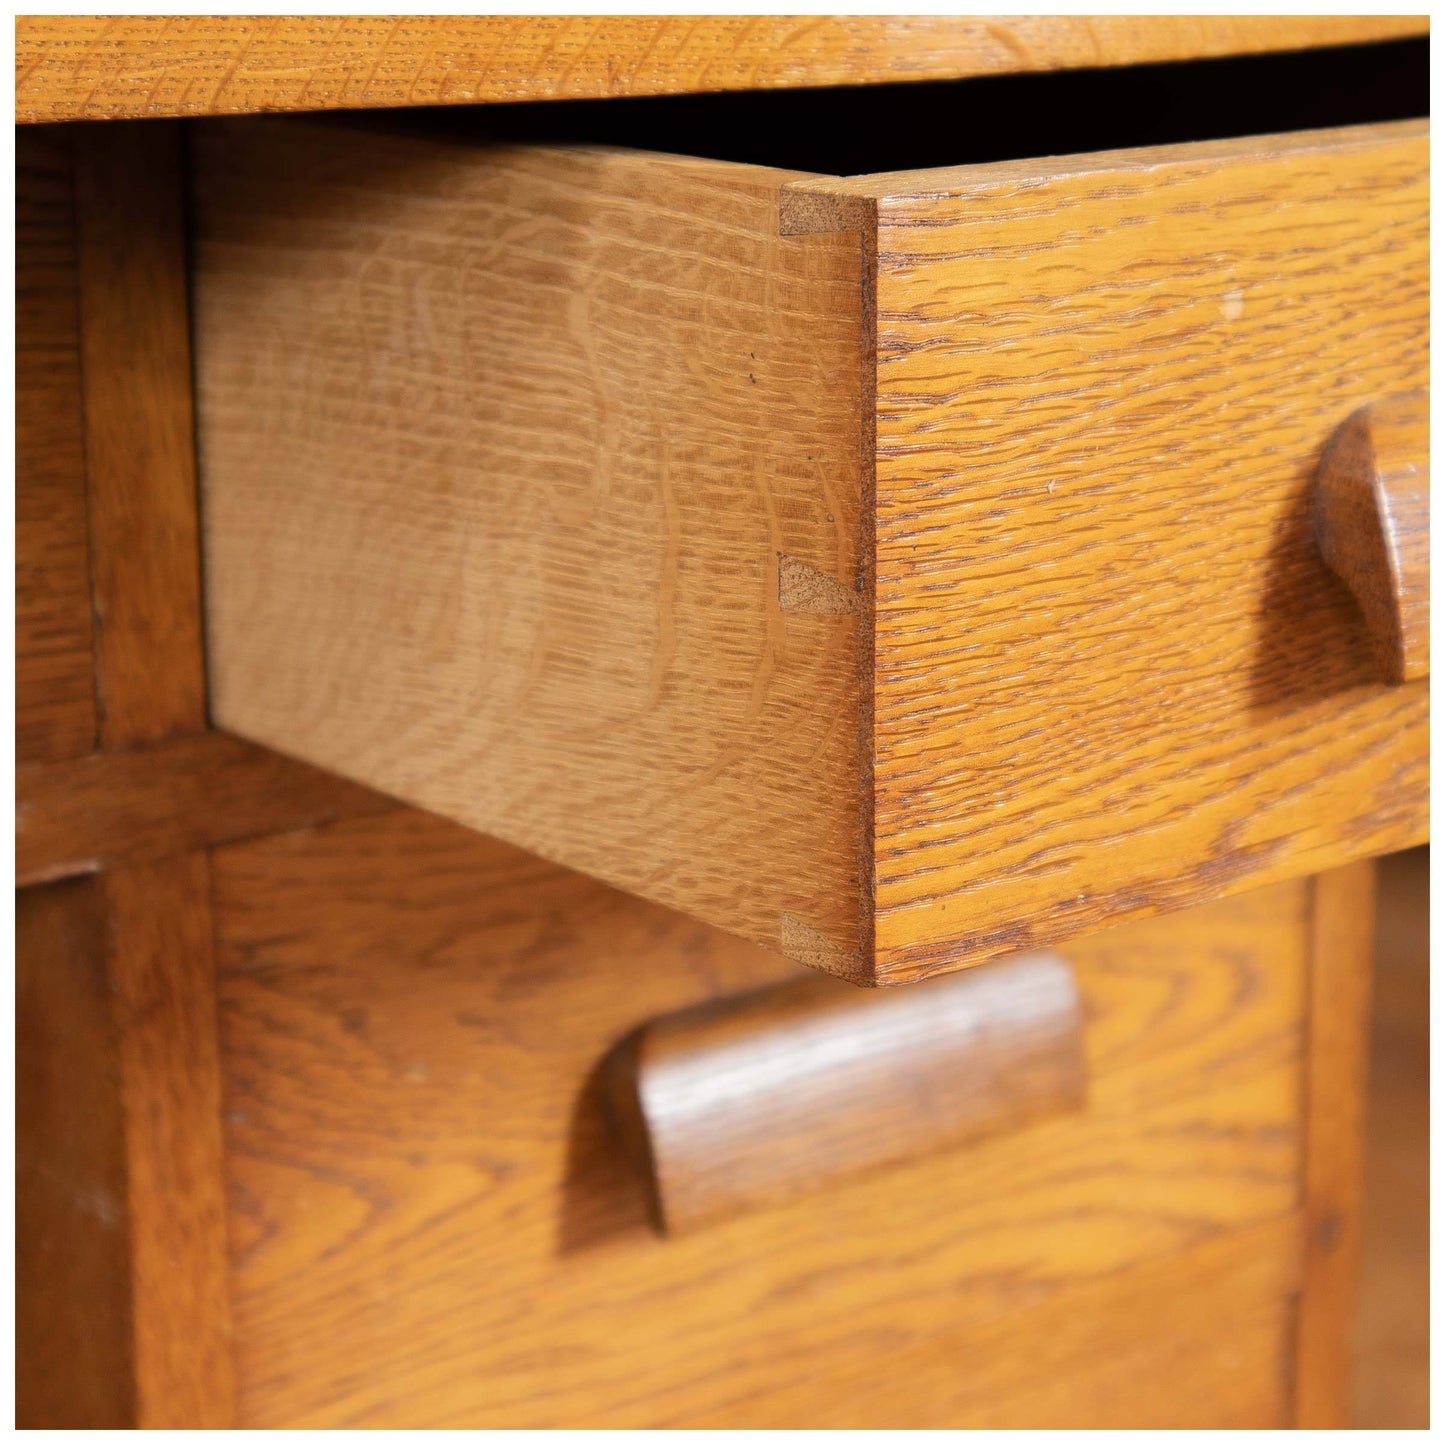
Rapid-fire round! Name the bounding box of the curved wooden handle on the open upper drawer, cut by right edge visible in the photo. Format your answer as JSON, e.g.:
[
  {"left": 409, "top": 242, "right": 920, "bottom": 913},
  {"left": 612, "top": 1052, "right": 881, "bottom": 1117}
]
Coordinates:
[{"left": 1315, "top": 392, "right": 1431, "bottom": 682}]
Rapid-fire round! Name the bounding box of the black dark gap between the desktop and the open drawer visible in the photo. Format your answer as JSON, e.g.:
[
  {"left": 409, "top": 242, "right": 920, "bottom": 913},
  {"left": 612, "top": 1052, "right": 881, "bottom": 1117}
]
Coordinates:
[{"left": 366, "top": 39, "right": 1429, "bottom": 175}]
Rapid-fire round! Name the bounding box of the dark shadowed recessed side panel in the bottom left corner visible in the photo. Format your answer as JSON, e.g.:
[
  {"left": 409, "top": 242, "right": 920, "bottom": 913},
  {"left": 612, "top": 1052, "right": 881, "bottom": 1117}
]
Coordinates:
[{"left": 14, "top": 880, "right": 134, "bottom": 1429}]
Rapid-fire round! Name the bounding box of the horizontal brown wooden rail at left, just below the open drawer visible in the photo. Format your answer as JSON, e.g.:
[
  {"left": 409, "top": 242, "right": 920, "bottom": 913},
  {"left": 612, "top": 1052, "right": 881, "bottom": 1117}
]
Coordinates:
[{"left": 14, "top": 733, "right": 396, "bottom": 887}]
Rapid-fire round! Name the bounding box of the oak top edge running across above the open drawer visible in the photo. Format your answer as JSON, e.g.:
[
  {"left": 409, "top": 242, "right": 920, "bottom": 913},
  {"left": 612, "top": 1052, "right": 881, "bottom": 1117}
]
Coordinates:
[{"left": 16, "top": 14, "right": 1429, "bottom": 121}]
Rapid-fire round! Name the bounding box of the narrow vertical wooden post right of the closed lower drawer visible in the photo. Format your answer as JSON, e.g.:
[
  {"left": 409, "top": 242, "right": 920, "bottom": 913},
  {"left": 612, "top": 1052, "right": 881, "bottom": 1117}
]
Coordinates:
[{"left": 1295, "top": 861, "right": 1374, "bottom": 1429}]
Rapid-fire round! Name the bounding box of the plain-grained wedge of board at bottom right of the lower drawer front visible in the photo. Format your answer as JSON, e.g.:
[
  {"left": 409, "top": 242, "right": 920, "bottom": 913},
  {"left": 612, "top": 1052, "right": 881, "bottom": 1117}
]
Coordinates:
[{"left": 710, "top": 1215, "right": 1303, "bottom": 1429}]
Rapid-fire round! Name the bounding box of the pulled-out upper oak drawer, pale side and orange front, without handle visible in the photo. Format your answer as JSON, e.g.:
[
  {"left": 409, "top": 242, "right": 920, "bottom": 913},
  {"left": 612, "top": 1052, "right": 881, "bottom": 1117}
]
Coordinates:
[{"left": 195, "top": 120, "right": 1428, "bottom": 981}]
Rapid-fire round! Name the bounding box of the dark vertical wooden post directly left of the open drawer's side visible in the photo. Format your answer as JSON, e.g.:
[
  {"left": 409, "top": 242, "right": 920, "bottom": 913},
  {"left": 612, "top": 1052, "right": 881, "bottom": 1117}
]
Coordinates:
[{"left": 75, "top": 124, "right": 207, "bottom": 747}]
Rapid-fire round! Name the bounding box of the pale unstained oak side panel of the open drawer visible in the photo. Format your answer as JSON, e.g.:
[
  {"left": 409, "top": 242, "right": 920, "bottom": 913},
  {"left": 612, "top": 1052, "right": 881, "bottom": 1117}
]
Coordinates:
[{"left": 197, "top": 121, "right": 863, "bottom": 972}]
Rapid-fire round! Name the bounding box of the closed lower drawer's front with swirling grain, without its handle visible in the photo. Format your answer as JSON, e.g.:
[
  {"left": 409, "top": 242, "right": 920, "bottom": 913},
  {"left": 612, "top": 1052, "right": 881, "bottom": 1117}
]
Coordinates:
[{"left": 214, "top": 812, "right": 1309, "bottom": 1428}]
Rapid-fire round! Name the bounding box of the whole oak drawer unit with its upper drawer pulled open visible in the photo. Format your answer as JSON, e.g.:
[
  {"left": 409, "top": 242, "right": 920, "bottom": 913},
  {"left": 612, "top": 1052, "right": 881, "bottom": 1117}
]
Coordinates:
[{"left": 17, "top": 17, "right": 1428, "bottom": 1428}]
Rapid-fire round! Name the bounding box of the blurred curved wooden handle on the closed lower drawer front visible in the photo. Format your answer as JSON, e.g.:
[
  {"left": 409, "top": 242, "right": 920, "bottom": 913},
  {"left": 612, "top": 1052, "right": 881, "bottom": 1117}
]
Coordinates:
[{"left": 608, "top": 954, "right": 1084, "bottom": 1233}]
